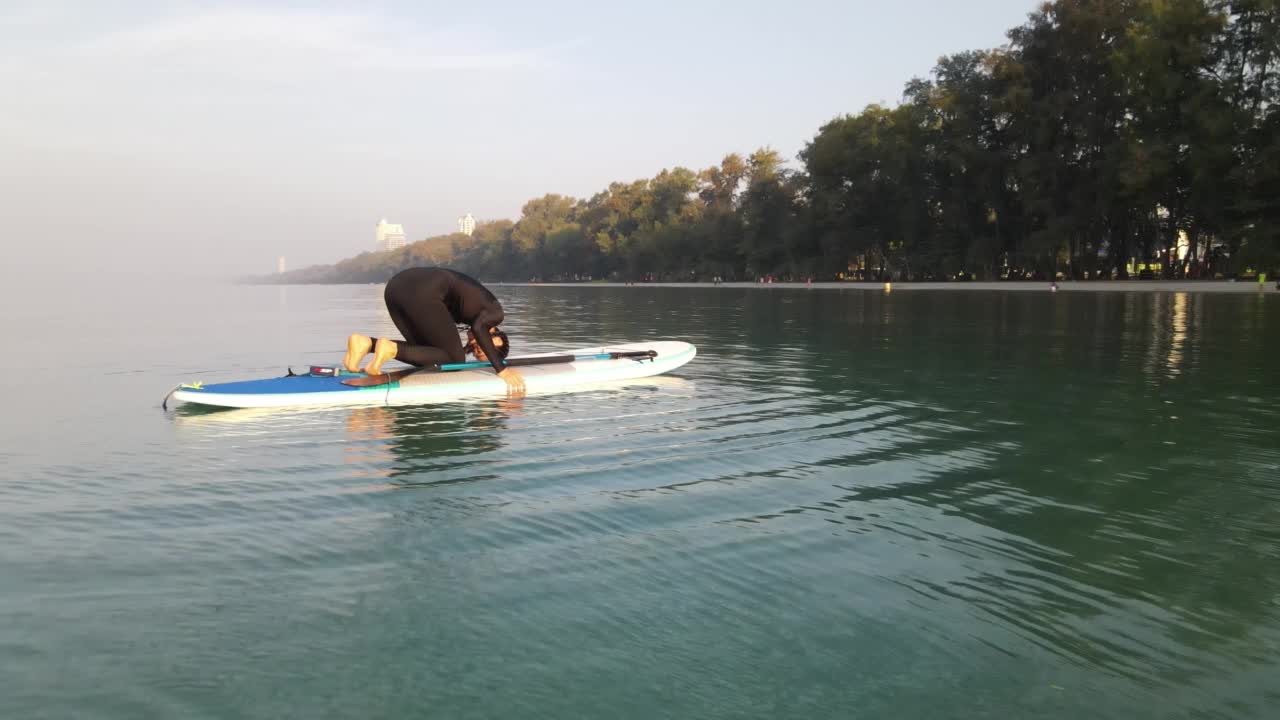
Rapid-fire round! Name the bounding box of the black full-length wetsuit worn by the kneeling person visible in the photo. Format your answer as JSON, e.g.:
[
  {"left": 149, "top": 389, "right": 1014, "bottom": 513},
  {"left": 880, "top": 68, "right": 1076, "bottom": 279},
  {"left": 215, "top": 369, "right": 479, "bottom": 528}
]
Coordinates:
[{"left": 383, "top": 268, "right": 503, "bottom": 372}]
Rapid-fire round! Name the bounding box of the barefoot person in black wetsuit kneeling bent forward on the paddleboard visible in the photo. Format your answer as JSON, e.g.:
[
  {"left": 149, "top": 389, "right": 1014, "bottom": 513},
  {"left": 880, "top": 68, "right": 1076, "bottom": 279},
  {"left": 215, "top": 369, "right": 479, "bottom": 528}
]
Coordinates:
[{"left": 343, "top": 268, "right": 525, "bottom": 395}]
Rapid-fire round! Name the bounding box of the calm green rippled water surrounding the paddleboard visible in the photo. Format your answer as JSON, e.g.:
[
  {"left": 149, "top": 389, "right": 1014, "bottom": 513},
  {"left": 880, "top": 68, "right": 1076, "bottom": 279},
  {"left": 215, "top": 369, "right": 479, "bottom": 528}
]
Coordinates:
[{"left": 0, "top": 284, "right": 1280, "bottom": 719}]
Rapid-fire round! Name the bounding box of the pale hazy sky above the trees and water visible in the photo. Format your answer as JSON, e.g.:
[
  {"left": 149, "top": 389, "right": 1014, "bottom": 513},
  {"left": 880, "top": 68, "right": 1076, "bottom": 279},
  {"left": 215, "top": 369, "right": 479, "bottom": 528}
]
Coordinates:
[{"left": 0, "top": 0, "right": 1037, "bottom": 277}]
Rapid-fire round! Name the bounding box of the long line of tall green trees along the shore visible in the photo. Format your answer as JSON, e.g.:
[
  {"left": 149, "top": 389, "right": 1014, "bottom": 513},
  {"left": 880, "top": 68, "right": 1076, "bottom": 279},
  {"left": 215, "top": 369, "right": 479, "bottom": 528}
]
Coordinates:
[{"left": 270, "top": 0, "right": 1280, "bottom": 282}]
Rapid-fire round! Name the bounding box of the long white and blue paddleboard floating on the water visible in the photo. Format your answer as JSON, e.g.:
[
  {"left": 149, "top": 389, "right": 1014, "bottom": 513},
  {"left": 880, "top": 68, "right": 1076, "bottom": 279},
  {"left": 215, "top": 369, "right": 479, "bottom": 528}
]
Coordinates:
[{"left": 172, "top": 341, "right": 698, "bottom": 407}]
